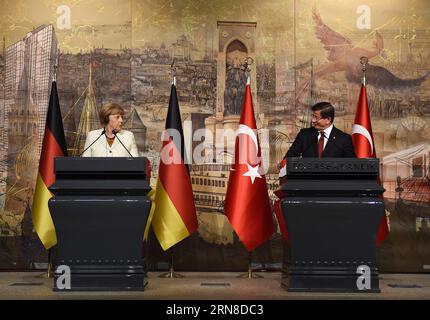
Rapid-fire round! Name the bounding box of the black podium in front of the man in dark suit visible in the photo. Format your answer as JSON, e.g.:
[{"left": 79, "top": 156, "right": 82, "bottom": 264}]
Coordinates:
[{"left": 280, "top": 158, "right": 385, "bottom": 292}]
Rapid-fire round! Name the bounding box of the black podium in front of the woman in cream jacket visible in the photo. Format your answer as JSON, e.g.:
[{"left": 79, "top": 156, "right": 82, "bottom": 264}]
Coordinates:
[{"left": 49, "top": 157, "right": 151, "bottom": 291}]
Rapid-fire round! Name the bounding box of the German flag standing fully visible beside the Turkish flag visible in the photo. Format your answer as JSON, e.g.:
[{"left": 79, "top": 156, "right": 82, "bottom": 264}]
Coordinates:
[{"left": 152, "top": 84, "right": 197, "bottom": 250}]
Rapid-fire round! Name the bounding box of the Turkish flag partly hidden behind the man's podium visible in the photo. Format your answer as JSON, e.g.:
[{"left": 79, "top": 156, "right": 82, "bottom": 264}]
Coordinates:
[{"left": 352, "top": 84, "right": 389, "bottom": 245}]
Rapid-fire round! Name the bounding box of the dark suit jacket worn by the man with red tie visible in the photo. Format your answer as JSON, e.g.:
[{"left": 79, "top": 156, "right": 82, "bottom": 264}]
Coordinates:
[{"left": 285, "top": 126, "right": 356, "bottom": 158}]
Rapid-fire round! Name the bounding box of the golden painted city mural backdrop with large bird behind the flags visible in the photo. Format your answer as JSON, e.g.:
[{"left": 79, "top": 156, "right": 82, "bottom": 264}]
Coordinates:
[{"left": 0, "top": 0, "right": 430, "bottom": 272}]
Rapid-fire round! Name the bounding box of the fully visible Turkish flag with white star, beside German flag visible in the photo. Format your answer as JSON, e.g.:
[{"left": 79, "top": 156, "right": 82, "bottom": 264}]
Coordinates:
[{"left": 224, "top": 81, "right": 274, "bottom": 252}]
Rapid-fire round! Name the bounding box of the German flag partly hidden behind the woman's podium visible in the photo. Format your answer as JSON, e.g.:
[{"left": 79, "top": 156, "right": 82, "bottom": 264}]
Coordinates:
[{"left": 32, "top": 81, "right": 67, "bottom": 249}]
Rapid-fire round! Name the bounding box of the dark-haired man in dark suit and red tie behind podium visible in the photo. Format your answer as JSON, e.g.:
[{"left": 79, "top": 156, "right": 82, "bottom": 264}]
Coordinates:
[{"left": 284, "top": 102, "right": 355, "bottom": 158}]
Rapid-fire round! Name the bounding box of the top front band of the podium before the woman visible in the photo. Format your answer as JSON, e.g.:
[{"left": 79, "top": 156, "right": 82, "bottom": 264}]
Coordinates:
[{"left": 54, "top": 157, "right": 147, "bottom": 174}]
